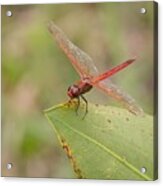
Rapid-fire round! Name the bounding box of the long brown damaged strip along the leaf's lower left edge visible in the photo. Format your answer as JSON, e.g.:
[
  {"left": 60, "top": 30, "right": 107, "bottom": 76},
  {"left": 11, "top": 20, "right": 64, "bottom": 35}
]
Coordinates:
[{"left": 61, "top": 138, "right": 84, "bottom": 178}]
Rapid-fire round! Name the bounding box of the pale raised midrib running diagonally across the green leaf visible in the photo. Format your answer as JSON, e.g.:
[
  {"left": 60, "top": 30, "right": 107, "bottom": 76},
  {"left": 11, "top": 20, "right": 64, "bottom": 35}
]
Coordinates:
[{"left": 46, "top": 114, "right": 152, "bottom": 180}]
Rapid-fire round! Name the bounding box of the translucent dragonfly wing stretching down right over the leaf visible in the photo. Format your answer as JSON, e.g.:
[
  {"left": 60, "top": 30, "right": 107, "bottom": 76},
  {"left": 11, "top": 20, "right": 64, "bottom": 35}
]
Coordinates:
[{"left": 94, "top": 79, "right": 144, "bottom": 115}]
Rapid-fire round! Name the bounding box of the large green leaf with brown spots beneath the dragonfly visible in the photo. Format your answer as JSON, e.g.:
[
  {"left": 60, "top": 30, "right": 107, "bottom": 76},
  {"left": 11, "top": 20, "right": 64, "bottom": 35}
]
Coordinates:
[{"left": 45, "top": 101, "right": 154, "bottom": 180}]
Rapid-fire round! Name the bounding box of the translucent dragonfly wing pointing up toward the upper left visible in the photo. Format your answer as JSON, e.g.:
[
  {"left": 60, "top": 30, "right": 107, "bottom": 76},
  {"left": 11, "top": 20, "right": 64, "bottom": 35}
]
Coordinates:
[{"left": 48, "top": 21, "right": 98, "bottom": 78}]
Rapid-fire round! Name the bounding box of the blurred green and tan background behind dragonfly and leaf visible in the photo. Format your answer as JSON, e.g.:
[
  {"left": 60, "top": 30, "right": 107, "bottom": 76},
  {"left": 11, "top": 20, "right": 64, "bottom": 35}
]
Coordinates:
[{"left": 2, "top": 2, "right": 153, "bottom": 178}]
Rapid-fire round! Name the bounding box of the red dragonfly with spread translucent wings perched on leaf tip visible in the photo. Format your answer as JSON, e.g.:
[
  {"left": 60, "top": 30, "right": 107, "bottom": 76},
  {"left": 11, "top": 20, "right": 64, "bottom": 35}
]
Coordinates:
[{"left": 48, "top": 21, "right": 143, "bottom": 115}]
